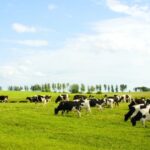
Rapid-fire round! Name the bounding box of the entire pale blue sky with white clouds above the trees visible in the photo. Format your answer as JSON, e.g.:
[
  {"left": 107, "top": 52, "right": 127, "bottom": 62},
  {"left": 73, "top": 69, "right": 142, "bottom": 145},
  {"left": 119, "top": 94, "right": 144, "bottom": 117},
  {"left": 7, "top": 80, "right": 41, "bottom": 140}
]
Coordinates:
[{"left": 0, "top": 0, "right": 150, "bottom": 88}]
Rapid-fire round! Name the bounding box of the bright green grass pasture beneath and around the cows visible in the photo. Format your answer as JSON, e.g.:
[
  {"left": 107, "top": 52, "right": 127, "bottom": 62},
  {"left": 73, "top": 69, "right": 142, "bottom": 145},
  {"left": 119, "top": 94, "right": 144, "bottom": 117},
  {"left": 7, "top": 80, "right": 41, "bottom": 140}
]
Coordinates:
[{"left": 0, "top": 91, "right": 150, "bottom": 150}]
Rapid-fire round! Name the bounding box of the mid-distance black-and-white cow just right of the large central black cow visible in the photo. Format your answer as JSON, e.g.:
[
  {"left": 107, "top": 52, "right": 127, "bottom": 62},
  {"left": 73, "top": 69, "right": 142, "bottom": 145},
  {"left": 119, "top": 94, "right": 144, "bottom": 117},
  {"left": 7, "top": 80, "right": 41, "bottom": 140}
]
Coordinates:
[{"left": 89, "top": 98, "right": 105, "bottom": 110}]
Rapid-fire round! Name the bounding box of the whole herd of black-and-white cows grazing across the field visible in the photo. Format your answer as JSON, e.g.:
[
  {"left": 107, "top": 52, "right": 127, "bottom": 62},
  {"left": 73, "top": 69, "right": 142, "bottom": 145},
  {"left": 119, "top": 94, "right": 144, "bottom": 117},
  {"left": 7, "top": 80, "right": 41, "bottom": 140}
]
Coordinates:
[{"left": 0, "top": 94, "right": 150, "bottom": 127}]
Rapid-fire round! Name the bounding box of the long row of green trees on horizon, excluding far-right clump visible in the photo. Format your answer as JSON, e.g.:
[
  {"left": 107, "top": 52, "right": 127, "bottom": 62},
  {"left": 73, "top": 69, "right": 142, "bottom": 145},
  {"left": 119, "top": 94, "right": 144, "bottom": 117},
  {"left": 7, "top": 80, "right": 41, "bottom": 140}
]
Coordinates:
[{"left": 0, "top": 83, "right": 130, "bottom": 93}]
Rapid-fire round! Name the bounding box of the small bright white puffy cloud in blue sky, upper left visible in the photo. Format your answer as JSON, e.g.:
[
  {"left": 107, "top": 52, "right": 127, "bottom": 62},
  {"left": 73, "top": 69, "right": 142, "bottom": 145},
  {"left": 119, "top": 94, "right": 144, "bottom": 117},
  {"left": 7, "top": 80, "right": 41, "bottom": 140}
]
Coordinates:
[{"left": 12, "top": 23, "right": 37, "bottom": 33}]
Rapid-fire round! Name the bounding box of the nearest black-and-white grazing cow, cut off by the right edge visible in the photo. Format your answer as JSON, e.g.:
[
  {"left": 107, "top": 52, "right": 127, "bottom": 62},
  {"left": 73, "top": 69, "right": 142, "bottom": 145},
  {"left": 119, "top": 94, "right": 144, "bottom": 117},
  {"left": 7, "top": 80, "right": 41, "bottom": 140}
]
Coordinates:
[{"left": 131, "top": 104, "right": 150, "bottom": 127}]
